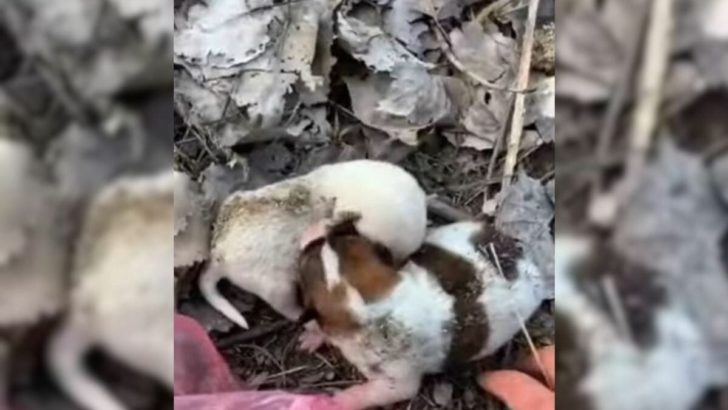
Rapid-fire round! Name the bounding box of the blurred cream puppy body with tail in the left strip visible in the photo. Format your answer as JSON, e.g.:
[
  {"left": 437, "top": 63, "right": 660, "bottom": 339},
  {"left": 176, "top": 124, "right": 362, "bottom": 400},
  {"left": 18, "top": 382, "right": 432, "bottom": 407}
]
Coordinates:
[{"left": 47, "top": 171, "right": 174, "bottom": 410}]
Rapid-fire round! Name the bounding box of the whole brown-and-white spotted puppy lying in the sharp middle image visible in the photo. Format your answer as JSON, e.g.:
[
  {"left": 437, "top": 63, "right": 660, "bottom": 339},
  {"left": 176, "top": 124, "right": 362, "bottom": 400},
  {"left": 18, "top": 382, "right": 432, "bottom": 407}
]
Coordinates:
[{"left": 299, "top": 222, "right": 546, "bottom": 409}]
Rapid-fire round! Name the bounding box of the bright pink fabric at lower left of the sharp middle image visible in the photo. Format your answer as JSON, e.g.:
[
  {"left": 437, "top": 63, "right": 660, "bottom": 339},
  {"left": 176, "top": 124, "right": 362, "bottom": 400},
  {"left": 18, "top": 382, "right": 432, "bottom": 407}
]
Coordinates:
[{"left": 174, "top": 314, "right": 346, "bottom": 410}]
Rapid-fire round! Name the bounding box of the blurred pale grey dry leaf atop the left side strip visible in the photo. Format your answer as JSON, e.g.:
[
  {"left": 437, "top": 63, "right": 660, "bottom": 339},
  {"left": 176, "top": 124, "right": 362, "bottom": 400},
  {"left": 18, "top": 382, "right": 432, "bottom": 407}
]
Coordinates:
[{"left": 0, "top": 0, "right": 173, "bottom": 103}]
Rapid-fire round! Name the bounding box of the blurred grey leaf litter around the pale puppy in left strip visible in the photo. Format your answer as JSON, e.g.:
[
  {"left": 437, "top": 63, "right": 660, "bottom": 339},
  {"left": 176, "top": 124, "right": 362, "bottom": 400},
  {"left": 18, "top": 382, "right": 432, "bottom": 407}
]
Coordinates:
[{"left": 0, "top": 0, "right": 174, "bottom": 410}]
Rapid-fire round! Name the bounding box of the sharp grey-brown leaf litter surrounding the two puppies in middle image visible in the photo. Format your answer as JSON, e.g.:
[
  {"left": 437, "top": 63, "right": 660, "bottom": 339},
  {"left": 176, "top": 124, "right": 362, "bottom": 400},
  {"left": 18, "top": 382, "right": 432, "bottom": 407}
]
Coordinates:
[{"left": 174, "top": 0, "right": 555, "bottom": 409}]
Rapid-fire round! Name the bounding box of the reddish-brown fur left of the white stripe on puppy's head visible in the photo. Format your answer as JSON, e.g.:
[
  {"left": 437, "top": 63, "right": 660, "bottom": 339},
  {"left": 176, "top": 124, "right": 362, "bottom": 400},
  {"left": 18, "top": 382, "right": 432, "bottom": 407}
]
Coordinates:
[{"left": 299, "top": 241, "right": 360, "bottom": 335}]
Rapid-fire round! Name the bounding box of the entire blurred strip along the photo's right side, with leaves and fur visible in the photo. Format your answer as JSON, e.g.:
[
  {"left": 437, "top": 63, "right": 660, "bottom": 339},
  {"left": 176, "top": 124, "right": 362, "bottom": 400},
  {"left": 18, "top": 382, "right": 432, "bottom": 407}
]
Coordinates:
[{"left": 556, "top": 0, "right": 728, "bottom": 410}]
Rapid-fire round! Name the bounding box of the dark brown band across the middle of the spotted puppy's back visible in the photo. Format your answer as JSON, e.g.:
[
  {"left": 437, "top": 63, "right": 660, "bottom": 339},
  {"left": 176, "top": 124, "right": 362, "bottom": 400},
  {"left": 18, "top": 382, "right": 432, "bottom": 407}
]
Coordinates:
[{"left": 412, "top": 244, "right": 489, "bottom": 367}]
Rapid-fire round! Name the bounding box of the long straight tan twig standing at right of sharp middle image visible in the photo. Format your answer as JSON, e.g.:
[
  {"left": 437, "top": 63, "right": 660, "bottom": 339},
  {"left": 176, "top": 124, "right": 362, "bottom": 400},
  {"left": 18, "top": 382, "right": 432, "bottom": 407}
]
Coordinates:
[{"left": 501, "top": 0, "right": 539, "bottom": 189}]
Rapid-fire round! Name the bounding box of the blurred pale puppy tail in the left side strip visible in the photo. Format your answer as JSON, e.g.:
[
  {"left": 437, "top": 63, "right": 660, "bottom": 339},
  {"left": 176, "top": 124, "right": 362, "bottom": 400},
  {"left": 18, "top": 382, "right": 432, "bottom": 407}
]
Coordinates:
[{"left": 46, "top": 323, "right": 127, "bottom": 410}]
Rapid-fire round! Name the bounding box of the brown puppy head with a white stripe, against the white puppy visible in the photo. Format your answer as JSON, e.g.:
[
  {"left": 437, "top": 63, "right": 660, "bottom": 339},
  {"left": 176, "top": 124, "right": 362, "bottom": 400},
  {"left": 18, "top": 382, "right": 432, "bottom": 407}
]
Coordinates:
[{"left": 299, "top": 220, "right": 399, "bottom": 334}]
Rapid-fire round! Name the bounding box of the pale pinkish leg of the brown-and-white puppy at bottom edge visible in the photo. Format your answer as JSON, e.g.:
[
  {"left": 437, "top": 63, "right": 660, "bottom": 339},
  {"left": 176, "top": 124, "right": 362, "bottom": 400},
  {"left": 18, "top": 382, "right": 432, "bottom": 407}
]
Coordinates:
[{"left": 334, "top": 375, "right": 422, "bottom": 410}]
